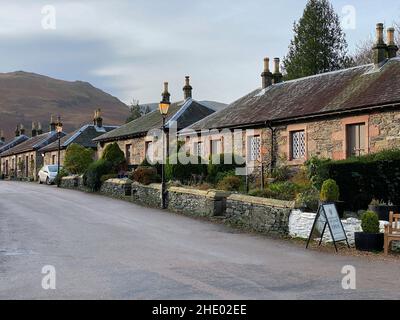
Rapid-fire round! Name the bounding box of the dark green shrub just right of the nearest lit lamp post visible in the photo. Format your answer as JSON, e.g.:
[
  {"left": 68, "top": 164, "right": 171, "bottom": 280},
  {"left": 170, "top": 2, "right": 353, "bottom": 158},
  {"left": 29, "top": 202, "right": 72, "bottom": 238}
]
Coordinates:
[{"left": 165, "top": 154, "right": 207, "bottom": 183}]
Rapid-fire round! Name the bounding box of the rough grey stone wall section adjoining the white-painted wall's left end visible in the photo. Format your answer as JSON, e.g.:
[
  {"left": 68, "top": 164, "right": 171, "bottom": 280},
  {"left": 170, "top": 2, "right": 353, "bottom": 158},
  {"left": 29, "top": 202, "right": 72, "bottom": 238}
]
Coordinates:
[{"left": 226, "top": 194, "right": 294, "bottom": 236}]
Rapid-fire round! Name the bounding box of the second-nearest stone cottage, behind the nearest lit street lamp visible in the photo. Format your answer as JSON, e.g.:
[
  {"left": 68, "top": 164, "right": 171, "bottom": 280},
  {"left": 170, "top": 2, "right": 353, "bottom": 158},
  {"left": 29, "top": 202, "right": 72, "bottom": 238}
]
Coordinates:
[{"left": 94, "top": 77, "right": 223, "bottom": 167}]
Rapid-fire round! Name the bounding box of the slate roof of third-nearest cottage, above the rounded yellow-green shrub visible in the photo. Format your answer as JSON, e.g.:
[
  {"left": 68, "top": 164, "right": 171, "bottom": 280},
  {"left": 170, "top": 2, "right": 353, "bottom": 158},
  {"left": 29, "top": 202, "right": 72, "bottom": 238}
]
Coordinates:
[{"left": 40, "top": 124, "right": 118, "bottom": 152}]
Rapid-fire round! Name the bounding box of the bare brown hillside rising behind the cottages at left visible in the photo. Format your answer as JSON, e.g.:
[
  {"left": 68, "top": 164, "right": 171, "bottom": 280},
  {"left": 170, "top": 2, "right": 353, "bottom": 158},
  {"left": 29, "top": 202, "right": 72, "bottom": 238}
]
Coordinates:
[{"left": 0, "top": 71, "right": 129, "bottom": 138}]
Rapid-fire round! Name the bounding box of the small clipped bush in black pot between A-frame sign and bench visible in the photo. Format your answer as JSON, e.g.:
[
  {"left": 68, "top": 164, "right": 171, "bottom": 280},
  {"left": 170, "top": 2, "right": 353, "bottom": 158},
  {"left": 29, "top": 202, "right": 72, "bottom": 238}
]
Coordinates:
[{"left": 354, "top": 211, "right": 384, "bottom": 252}]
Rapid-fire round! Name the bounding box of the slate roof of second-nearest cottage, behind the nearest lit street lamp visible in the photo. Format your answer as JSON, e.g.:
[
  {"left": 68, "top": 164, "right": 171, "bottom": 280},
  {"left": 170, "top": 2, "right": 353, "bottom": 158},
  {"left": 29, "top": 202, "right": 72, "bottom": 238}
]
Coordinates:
[{"left": 94, "top": 99, "right": 215, "bottom": 141}]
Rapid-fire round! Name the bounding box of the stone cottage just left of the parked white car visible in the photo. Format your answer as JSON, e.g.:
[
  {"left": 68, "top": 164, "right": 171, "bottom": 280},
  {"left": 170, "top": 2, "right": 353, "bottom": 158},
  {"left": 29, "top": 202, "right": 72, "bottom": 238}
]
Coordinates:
[{"left": 0, "top": 121, "right": 65, "bottom": 180}]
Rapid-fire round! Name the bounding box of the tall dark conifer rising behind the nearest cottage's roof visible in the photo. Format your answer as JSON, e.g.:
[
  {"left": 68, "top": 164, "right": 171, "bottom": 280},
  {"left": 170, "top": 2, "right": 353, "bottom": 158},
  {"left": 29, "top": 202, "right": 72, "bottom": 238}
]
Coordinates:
[{"left": 283, "top": 0, "right": 351, "bottom": 80}]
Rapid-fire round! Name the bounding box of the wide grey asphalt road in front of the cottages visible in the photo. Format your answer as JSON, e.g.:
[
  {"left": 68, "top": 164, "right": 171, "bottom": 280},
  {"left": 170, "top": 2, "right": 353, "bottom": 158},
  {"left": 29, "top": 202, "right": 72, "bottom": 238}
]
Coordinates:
[{"left": 0, "top": 181, "right": 400, "bottom": 299}]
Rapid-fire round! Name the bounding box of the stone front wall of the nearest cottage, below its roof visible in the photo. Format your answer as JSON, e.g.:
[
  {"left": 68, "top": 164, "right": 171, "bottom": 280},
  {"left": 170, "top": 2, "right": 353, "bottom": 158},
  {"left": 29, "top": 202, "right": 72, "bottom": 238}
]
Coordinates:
[{"left": 183, "top": 110, "right": 400, "bottom": 172}]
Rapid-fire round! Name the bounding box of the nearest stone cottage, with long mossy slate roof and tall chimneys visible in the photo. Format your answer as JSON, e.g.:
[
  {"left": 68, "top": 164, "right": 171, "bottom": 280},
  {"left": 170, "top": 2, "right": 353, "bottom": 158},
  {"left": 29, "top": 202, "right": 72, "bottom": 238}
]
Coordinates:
[{"left": 186, "top": 24, "right": 400, "bottom": 174}]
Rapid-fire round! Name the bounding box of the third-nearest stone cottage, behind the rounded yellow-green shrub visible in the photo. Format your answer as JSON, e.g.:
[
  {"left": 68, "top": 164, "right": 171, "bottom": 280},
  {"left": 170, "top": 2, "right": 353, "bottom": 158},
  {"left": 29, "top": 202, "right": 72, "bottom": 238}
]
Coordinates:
[{"left": 39, "top": 109, "right": 118, "bottom": 165}]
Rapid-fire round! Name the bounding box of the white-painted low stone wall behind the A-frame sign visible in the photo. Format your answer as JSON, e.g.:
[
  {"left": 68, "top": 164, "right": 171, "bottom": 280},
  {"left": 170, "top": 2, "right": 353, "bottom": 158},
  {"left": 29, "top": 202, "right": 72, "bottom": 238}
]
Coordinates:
[{"left": 289, "top": 210, "right": 400, "bottom": 251}]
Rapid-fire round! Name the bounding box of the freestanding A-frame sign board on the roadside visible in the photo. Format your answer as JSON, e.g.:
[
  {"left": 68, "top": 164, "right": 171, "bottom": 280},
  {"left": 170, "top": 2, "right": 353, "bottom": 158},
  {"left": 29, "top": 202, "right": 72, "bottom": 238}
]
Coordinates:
[{"left": 306, "top": 203, "right": 350, "bottom": 251}]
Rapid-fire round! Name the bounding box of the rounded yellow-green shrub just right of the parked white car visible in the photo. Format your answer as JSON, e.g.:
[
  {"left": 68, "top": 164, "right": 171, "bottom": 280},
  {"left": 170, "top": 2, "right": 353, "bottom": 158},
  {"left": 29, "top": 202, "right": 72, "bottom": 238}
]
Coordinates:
[{"left": 64, "top": 143, "right": 94, "bottom": 174}]
